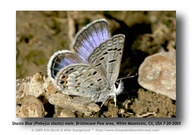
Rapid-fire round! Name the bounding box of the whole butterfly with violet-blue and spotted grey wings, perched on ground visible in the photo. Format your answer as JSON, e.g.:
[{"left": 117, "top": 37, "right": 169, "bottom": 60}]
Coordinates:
[{"left": 47, "top": 19, "right": 125, "bottom": 106}]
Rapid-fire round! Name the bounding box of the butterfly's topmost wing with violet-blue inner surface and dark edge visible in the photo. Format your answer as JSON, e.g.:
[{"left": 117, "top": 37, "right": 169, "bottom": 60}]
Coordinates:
[{"left": 71, "top": 19, "right": 110, "bottom": 62}]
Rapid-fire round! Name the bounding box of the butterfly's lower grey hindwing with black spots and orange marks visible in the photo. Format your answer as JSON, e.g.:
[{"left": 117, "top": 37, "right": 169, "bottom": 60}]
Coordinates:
[{"left": 55, "top": 63, "right": 108, "bottom": 102}]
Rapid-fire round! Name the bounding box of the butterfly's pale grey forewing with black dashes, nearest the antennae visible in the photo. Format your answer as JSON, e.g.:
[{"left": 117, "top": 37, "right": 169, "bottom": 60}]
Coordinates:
[{"left": 88, "top": 34, "right": 125, "bottom": 86}]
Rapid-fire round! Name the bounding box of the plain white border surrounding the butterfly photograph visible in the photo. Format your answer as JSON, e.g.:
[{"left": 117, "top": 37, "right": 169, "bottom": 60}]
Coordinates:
[{"left": 0, "top": 0, "right": 192, "bottom": 135}]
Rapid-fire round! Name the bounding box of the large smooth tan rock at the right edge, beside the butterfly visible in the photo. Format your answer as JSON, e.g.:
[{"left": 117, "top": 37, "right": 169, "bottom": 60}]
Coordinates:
[{"left": 138, "top": 51, "right": 176, "bottom": 100}]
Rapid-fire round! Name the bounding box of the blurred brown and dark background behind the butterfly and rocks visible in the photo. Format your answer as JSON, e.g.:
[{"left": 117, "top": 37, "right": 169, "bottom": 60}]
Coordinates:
[{"left": 16, "top": 11, "right": 176, "bottom": 79}]
